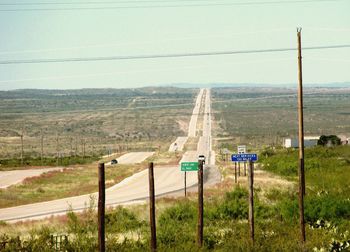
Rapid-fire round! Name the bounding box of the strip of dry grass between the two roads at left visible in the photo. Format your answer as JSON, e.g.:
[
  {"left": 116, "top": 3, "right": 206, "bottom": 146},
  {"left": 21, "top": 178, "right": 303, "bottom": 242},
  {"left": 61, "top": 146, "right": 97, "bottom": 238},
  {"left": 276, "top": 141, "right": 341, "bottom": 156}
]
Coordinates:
[{"left": 0, "top": 163, "right": 146, "bottom": 208}]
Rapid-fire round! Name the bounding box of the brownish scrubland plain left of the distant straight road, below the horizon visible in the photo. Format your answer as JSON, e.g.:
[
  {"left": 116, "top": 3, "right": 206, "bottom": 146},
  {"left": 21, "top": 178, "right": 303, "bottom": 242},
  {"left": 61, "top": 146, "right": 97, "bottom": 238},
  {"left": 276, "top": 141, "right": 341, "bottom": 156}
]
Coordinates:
[{"left": 0, "top": 88, "right": 197, "bottom": 159}]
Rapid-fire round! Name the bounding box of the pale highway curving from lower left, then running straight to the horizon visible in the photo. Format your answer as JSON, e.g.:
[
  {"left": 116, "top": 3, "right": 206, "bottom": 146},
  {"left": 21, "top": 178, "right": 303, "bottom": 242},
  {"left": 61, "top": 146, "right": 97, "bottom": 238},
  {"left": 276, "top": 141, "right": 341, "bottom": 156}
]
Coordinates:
[{"left": 0, "top": 89, "right": 220, "bottom": 222}]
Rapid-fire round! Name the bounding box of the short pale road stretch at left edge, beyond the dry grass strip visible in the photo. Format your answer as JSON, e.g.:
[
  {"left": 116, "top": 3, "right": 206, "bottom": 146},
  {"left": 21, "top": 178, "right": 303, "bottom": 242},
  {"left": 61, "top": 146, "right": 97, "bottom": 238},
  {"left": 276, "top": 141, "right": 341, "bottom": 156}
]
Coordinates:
[{"left": 0, "top": 167, "right": 63, "bottom": 188}]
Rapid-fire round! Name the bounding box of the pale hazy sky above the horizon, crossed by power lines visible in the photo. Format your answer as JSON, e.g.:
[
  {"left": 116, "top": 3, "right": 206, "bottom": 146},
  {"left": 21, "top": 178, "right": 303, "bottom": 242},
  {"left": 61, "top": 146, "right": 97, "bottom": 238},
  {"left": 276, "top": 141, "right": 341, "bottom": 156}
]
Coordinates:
[{"left": 0, "top": 0, "right": 350, "bottom": 90}]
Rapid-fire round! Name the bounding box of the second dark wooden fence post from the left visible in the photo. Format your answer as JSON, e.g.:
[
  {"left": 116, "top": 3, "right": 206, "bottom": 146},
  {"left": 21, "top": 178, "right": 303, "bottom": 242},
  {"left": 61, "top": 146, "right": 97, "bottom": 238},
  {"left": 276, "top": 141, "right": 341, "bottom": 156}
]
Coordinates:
[{"left": 148, "top": 162, "right": 157, "bottom": 251}]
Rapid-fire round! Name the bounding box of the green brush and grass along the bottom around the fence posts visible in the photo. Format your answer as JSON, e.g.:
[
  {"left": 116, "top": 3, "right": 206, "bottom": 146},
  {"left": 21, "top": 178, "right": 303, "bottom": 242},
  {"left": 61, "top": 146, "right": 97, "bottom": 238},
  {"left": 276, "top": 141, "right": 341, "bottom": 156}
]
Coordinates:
[{"left": 0, "top": 187, "right": 347, "bottom": 251}]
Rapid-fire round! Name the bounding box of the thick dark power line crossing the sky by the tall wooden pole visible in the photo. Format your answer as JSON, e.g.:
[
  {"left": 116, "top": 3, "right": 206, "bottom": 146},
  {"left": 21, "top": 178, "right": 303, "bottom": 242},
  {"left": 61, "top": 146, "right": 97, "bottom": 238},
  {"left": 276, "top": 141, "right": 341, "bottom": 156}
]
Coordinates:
[{"left": 0, "top": 44, "right": 350, "bottom": 65}]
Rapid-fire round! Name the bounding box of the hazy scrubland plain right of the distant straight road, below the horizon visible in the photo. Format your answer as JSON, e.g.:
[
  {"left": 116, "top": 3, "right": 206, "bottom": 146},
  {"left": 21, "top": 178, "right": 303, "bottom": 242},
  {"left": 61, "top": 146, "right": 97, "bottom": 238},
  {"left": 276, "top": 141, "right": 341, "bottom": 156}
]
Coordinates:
[{"left": 212, "top": 87, "right": 350, "bottom": 148}]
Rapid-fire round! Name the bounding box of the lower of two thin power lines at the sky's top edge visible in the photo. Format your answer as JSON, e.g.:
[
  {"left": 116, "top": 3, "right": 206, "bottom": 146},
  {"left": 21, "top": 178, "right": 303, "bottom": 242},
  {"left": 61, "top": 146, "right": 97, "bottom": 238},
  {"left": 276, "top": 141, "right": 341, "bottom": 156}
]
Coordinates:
[{"left": 0, "top": 0, "right": 345, "bottom": 12}]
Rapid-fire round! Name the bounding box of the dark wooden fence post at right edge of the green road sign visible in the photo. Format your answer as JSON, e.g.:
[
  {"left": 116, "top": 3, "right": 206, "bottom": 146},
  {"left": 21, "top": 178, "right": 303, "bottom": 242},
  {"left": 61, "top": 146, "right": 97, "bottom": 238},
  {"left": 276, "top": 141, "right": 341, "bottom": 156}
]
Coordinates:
[{"left": 197, "top": 160, "right": 203, "bottom": 247}]
